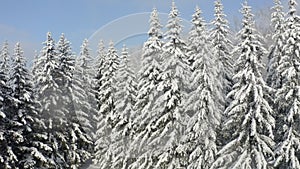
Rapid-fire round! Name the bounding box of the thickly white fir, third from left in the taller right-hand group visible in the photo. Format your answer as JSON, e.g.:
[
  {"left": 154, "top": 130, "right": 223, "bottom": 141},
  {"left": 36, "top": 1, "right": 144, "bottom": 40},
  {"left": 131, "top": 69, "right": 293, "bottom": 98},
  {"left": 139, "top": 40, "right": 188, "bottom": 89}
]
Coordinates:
[{"left": 181, "top": 7, "right": 221, "bottom": 169}]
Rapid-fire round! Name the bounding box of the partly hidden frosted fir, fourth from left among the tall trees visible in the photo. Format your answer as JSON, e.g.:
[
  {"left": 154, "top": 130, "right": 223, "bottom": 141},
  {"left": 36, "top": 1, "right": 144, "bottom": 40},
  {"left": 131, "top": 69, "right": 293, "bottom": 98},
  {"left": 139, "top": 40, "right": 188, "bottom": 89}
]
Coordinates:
[{"left": 209, "top": 0, "right": 233, "bottom": 104}]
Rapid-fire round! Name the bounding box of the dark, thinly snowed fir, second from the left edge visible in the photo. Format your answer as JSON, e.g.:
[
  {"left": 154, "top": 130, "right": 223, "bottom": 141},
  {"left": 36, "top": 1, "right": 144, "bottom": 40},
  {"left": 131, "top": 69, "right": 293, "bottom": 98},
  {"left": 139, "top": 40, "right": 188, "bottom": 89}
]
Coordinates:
[{"left": 7, "top": 43, "right": 47, "bottom": 168}]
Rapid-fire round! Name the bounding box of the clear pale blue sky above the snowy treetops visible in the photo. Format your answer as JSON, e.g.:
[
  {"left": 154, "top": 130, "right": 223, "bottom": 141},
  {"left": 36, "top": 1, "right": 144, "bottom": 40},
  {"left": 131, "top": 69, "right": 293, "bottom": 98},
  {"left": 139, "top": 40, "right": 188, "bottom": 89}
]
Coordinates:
[{"left": 0, "top": 0, "right": 273, "bottom": 60}]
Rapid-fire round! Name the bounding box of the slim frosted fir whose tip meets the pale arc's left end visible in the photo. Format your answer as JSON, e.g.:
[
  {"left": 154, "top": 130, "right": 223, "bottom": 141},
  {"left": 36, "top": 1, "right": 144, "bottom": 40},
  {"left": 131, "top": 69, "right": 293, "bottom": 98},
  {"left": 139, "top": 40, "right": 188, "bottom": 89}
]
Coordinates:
[{"left": 70, "top": 40, "right": 96, "bottom": 168}]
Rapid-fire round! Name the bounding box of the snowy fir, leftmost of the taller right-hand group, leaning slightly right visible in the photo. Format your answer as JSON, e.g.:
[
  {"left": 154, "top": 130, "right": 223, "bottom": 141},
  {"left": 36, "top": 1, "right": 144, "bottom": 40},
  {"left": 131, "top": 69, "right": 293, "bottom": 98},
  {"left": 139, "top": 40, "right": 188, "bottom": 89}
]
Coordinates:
[{"left": 129, "top": 9, "right": 163, "bottom": 162}]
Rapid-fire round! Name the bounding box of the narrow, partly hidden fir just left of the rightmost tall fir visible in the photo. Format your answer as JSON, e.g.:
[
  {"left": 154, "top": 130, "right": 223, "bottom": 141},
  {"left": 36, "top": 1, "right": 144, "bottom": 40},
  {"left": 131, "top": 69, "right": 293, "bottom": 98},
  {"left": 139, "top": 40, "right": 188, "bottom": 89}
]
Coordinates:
[{"left": 267, "top": 0, "right": 285, "bottom": 89}]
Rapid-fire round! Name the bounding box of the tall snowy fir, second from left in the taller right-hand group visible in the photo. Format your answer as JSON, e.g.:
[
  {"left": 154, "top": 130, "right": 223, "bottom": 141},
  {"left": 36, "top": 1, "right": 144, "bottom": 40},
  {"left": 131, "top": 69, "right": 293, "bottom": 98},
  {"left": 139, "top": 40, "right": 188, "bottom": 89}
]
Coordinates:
[{"left": 131, "top": 2, "right": 189, "bottom": 168}]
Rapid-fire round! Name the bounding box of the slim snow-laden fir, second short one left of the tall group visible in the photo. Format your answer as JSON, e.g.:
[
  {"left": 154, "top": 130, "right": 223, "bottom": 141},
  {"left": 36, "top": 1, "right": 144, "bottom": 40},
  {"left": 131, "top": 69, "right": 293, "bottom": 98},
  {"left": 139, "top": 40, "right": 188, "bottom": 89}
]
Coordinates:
[{"left": 94, "top": 42, "right": 119, "bottom": 169}]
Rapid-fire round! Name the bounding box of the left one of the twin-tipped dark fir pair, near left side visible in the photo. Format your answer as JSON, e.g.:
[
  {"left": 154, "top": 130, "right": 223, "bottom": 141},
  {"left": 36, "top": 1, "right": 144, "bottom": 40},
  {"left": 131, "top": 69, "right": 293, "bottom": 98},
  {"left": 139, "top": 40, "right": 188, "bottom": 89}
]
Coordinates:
[{"left": 36, "top": 33, "right": 68, "bottom": 168}]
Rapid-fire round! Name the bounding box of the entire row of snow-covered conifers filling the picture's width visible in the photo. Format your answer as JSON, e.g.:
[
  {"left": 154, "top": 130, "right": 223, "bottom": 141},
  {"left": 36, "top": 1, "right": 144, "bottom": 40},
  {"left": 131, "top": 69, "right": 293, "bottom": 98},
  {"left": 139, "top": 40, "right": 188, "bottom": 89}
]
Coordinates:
[{"left": 0, "top": 0, "right": 300, "bottom": 169}]
